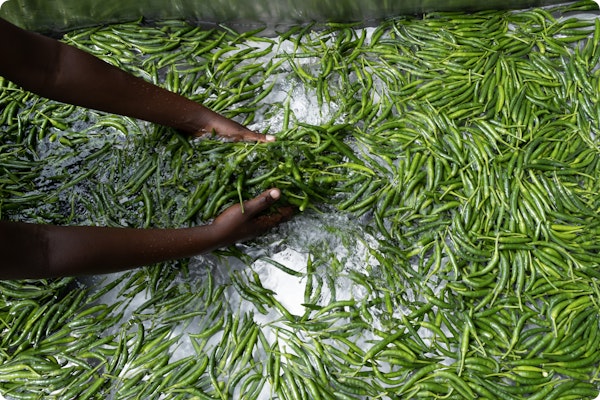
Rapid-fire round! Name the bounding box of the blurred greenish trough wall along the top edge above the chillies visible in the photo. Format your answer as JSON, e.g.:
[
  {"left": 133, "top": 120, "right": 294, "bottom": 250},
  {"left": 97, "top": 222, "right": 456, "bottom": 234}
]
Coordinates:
[{"left": 0, "top": 0, "right": 564, "bottom": 32}]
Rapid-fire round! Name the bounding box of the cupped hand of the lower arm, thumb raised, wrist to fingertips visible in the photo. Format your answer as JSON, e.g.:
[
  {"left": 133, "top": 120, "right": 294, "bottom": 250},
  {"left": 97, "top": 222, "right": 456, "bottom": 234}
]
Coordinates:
[{"left": 210, "top": 189, "right": 294, "bottom": 247}]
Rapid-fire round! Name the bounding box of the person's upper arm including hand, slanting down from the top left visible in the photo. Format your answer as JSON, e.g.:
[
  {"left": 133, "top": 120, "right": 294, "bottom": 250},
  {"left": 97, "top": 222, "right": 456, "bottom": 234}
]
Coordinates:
[{"left": 0, "top": 18, "right": 274, "bottom": 142}]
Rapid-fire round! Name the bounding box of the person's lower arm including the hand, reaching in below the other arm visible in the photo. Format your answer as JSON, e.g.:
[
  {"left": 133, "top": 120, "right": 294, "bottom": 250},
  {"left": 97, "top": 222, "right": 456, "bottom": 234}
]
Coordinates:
[{"left": 0, "top": 189, "right": 292, "bottom": 279}]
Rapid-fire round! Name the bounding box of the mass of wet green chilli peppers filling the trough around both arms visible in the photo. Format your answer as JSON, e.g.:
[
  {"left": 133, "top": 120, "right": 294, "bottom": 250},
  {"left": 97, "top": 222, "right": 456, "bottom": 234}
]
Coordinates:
[{"left": 0, "top": 2, "right": 600, "bottom": 399}]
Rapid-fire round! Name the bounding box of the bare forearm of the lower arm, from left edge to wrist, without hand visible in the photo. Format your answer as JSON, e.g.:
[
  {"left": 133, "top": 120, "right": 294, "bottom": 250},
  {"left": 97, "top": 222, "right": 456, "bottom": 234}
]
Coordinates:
[{"left": 0, "top": 222, "right": 220, "bottom": 279}]
